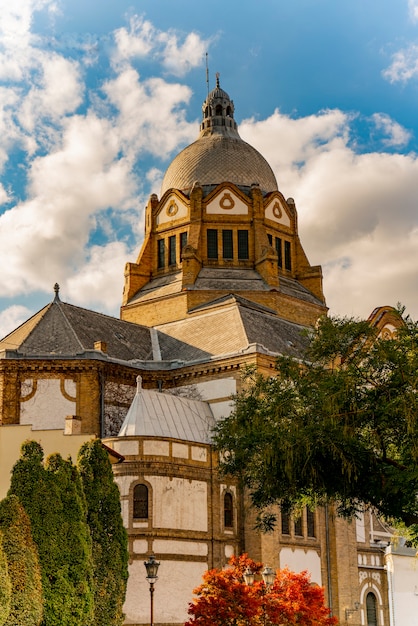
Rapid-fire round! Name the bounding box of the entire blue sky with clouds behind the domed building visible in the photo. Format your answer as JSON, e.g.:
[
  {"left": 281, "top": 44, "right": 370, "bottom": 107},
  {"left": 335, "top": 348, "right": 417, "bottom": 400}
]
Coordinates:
[{"left": 0, "top": 0, "right": 418, "bottom": 335}]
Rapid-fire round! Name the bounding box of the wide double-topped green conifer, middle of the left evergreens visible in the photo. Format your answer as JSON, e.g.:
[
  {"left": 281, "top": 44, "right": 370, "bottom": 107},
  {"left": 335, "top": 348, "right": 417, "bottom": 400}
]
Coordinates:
[{"left": 9, "top": 441, "right": 93, "bottom": 626}]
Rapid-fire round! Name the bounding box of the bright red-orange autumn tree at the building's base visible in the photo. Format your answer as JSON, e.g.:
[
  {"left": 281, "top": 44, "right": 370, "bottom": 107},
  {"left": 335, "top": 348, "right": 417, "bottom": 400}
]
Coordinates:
[{"left": 185, "top": 554, "right": 337, "bottom": 626}]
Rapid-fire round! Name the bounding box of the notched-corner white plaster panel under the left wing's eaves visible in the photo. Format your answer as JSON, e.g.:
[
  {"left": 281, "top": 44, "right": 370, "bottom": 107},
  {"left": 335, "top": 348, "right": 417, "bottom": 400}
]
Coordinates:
[{"left": 20, "top": 378, "right": 76, "bottom": 430}]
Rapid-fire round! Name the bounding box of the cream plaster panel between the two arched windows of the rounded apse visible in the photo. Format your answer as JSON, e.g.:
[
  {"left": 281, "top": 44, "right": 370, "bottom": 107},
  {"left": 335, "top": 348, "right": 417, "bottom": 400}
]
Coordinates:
[{"left": 145, "top": 476, "right": 208, "bottom": 532}]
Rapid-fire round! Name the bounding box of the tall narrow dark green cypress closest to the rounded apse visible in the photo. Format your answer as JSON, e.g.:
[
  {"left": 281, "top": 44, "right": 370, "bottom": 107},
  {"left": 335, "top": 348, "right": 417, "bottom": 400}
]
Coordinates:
[{"left": 78, "top": 439, "right": 128, "bottom": 626}]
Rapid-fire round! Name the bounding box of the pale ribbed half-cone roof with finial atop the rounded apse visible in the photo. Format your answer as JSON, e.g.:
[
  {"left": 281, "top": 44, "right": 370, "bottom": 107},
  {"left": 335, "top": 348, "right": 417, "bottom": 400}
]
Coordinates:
[{"left": 118, "top": 376, "right": 215, "bottom": 443}]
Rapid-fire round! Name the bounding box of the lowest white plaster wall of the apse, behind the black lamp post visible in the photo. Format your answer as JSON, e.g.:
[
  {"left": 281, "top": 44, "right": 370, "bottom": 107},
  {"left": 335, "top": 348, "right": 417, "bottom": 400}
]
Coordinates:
[{"left": 124, "top": 559, "right": 208, "bottom": 624}]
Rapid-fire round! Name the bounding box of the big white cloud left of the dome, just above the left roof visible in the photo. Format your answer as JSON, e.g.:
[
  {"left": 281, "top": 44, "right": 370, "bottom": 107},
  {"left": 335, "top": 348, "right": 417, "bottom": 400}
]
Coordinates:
[{"left": 0, "top": 115, "right": 136, "bottom": 295}]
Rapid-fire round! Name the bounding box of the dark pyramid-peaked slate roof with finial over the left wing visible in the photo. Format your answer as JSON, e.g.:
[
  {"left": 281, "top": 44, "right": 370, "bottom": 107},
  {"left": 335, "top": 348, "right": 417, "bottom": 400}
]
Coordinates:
[{"left": 0, "top": 297, "right": 153, "bottom": 361}]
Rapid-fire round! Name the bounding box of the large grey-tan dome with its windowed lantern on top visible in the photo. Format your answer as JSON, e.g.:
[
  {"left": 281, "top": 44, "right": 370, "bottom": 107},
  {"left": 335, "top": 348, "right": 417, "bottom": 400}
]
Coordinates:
[{"left": 161, "top": 78, "right": 277, "bottom": 196}]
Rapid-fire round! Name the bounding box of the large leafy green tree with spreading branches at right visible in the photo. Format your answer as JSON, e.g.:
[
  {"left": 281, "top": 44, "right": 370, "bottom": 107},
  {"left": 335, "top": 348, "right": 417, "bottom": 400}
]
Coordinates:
[{"left": 215, "top": 317, "right": 418, "bottom": 539}]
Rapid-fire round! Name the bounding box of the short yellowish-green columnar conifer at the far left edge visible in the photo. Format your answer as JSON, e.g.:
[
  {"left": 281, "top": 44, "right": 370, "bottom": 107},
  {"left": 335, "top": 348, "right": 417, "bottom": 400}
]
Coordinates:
[{"left": 0, "top": 495, "right": 43, "bottom": 626}]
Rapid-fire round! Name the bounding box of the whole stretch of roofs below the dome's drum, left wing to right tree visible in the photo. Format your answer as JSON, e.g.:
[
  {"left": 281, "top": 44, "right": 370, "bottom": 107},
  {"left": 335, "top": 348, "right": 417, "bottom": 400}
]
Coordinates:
[{"left": 0, "top": 294, "right": 307, "bottom": 367}]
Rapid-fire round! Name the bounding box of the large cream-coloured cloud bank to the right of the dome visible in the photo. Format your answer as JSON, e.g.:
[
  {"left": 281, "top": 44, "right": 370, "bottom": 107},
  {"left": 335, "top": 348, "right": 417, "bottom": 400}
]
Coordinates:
[{"left": 241, "top": 111, "right": 418, "bottom": 316}]
